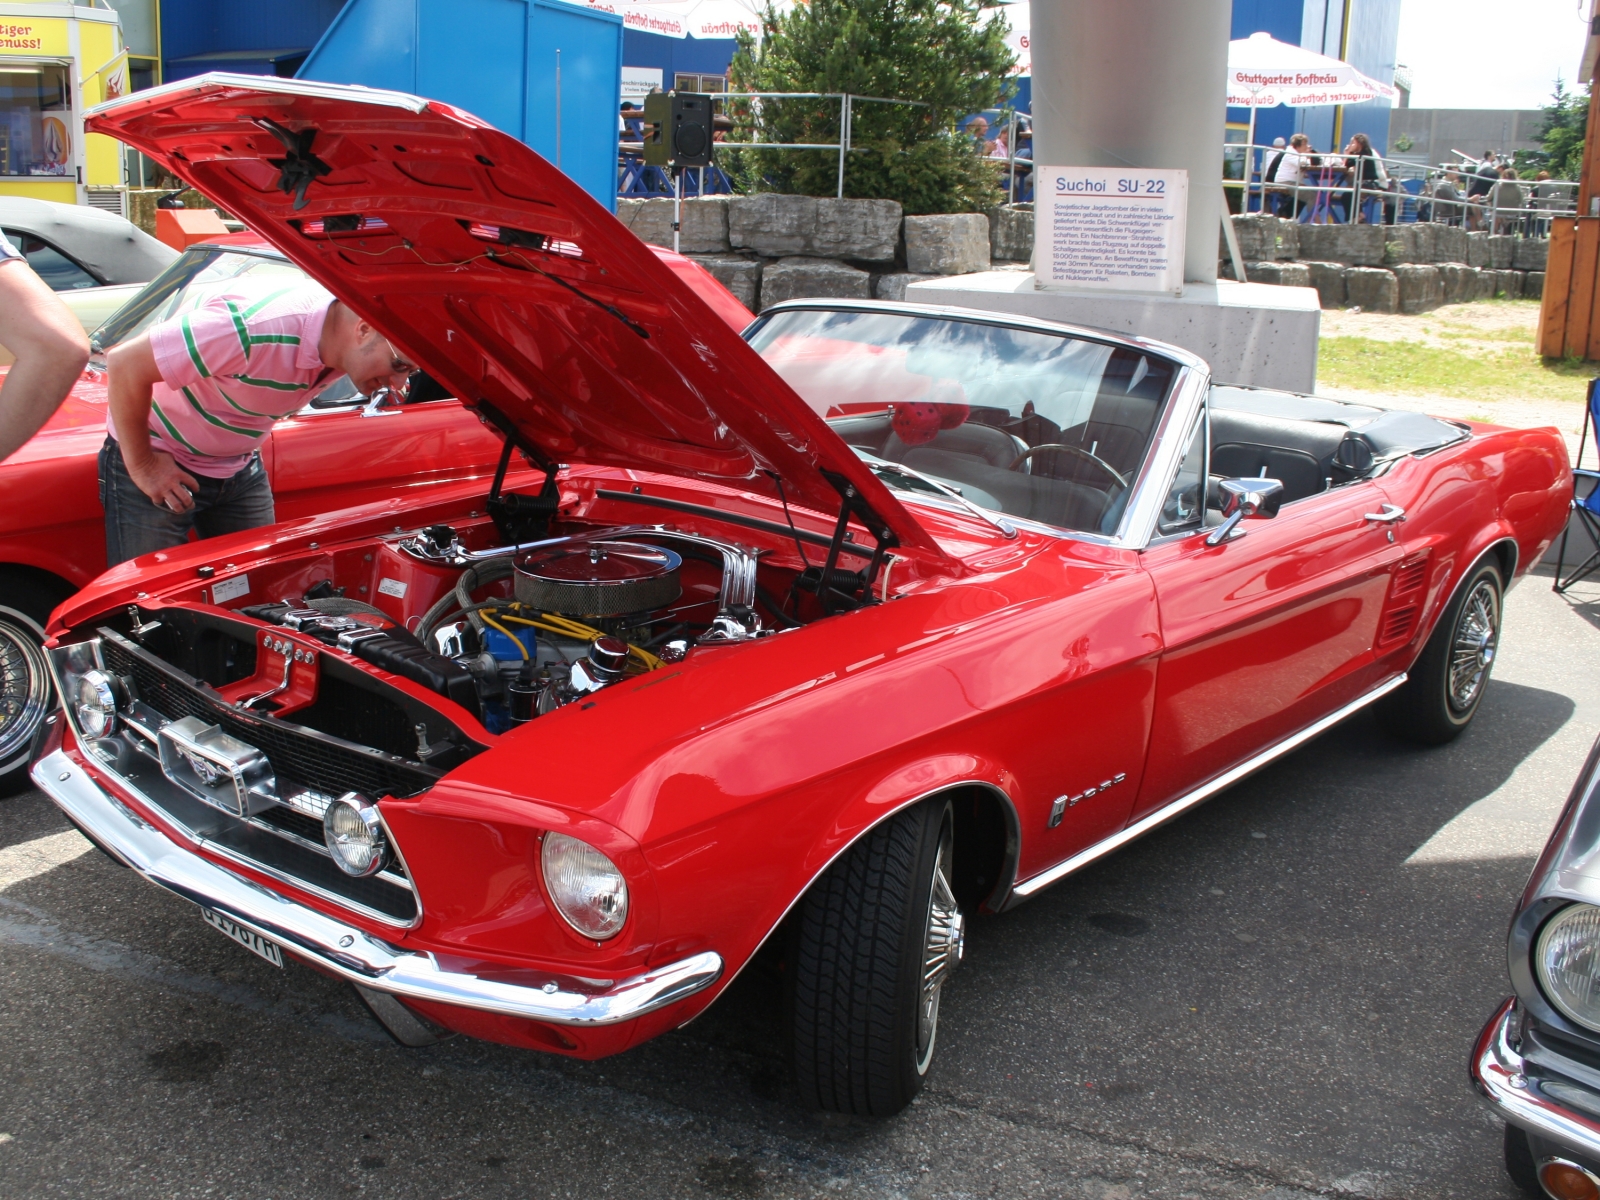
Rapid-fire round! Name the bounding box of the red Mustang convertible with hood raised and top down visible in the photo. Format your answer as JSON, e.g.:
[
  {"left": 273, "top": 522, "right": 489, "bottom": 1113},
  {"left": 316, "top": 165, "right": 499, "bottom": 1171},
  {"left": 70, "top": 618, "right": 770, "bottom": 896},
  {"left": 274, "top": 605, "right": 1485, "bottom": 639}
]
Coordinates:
[{"left": 32, "top": 75, "right": 1571, "bottom": 1115}]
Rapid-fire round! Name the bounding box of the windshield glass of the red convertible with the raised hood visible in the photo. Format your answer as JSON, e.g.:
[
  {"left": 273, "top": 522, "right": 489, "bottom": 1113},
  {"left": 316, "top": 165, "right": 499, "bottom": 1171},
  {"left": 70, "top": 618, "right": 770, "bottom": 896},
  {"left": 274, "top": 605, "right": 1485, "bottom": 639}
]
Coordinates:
[{"left": 750, "top": 309, "right": 1178, "bottom": 533}]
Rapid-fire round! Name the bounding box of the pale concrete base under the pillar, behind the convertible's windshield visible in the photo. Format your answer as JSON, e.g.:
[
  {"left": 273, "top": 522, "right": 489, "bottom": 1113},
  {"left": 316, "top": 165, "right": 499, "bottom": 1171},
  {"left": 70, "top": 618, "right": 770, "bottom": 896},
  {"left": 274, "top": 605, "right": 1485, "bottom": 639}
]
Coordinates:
[{"left": 906, "top": 270, "right": 1322, "bottom": 392}]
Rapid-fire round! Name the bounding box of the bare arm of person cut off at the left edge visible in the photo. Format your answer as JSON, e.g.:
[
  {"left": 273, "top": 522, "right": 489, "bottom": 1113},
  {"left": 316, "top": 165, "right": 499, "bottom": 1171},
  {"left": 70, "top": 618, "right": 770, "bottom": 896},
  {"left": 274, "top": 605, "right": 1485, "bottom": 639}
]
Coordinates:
[{"left": 0, "top": 259, "right": 90, "bottom": 462}]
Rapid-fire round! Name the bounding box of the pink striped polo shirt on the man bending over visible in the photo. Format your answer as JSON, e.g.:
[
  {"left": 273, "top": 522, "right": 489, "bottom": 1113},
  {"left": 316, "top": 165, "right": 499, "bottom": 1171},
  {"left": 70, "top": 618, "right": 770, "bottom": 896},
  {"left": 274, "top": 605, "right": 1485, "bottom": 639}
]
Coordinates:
[{"left": 116, "top": 277, "right": 338, "bottom": 478}]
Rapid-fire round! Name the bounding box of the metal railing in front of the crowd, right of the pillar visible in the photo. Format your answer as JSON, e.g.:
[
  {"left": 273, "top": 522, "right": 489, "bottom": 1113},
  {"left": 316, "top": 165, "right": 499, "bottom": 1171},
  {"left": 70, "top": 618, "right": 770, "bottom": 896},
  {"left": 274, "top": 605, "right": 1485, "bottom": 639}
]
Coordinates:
[{"left": 1222, "top": 142, "right": 1578, "bottom": 237}]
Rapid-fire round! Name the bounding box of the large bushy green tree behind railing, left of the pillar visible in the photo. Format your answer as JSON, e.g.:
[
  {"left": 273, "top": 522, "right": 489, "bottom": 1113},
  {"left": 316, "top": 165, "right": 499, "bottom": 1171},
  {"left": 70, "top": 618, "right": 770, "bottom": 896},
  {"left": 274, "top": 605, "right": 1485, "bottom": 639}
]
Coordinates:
[{"left": 730, "top": 0, "right": 1016, "bottom": 213}]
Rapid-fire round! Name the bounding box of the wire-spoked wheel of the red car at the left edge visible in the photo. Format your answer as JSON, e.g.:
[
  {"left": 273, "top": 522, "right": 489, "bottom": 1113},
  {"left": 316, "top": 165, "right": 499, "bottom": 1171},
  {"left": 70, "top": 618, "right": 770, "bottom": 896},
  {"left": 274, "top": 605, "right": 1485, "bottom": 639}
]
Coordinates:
[{"left": 0, "top": 573, "right": 72, "bottom": 797}]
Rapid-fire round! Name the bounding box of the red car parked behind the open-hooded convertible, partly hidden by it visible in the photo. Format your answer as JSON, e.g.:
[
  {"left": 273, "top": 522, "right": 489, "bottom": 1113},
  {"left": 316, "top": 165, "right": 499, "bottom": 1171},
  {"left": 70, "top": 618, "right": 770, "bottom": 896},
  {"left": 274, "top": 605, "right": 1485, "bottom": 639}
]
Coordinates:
[{"left": 0, "top": 234, "right": 755, "bottom": 795}]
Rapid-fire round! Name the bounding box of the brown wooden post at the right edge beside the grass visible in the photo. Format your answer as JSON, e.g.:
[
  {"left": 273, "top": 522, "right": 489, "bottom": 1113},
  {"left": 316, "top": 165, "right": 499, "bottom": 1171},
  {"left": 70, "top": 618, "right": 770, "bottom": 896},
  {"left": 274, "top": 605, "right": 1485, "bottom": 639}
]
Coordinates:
[{"left": 1538, "top": 78, "right": 1600, "bottom": 358}]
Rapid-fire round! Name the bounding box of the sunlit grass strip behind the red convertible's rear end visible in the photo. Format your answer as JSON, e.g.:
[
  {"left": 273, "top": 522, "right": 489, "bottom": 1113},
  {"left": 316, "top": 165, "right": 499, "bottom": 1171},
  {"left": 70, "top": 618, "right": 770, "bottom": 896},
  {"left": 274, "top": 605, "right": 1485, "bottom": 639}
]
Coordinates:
[{"left": 1317, "top": 338, "right": 1597, "bottom": 403}]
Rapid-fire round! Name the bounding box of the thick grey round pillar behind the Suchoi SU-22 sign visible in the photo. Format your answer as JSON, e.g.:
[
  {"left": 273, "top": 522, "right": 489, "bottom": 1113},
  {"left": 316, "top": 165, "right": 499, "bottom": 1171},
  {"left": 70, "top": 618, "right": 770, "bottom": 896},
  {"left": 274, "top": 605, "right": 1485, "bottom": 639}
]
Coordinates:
[{"left": 1030, "top": 0, "right": 1232, "bottom": 283}]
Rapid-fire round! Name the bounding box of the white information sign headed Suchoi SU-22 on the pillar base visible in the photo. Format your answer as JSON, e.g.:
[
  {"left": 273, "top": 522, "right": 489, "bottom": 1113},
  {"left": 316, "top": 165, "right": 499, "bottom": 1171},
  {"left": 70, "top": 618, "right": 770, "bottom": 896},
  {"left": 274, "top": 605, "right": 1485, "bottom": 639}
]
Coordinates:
[{"left": 1034, "top": 166, "right": 1189, "bottom": 294}]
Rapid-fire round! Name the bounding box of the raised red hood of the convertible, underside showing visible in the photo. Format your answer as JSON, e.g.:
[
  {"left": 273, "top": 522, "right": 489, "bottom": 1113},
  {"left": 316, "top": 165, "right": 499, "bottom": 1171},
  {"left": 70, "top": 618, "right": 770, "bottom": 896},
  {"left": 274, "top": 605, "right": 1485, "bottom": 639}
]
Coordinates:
[{"left": 86, "top": 75, "right": 939, "bottom": 554}]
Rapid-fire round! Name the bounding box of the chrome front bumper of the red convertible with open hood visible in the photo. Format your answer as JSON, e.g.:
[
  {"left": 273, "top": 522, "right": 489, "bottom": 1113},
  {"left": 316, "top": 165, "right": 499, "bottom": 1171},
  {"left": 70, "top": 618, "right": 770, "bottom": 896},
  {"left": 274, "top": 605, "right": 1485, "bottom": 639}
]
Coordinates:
[{"left": 32, "top": 750, "right": 722, "bottom": 1026}]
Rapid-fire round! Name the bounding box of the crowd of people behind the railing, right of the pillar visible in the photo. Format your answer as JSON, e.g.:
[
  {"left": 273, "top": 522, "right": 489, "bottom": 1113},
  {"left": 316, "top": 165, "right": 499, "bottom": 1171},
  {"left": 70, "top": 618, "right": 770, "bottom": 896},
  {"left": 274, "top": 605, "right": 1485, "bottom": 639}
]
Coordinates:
[{"left": 1261, "top": 133, "right": 1571, "bottom": 237}]
